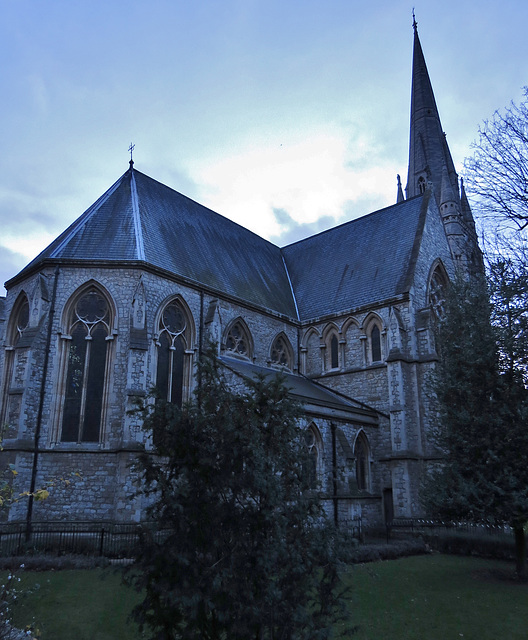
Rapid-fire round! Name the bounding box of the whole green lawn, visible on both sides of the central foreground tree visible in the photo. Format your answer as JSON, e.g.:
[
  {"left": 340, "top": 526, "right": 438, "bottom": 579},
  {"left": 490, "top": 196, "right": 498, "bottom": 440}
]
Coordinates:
[{"left": 6, "top": 555, "right": 528, "bottom": 640}]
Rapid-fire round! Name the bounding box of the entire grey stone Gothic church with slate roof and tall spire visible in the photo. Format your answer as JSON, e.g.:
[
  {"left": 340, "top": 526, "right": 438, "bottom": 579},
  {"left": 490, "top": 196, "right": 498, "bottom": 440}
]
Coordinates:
[{"left": 0, "top": 24, "right": 480, "bottom": 526}]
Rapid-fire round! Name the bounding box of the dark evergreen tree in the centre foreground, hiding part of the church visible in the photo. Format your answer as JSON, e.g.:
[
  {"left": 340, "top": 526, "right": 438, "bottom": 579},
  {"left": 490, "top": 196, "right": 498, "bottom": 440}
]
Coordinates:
[{"left": 127, "top": 349, "right": 352, "bottom": 640}]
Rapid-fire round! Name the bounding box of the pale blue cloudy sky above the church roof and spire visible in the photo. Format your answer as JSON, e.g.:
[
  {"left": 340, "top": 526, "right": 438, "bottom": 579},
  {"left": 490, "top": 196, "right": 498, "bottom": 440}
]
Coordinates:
[{"left": 0, "top": 0, "right": 528, "bottom": 295}]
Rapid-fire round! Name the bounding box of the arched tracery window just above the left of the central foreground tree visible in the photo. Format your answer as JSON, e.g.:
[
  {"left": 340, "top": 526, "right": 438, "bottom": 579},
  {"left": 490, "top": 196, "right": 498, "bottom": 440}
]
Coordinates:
[{"left": 156, "top": 300, "right": 189, "bottom": 407}]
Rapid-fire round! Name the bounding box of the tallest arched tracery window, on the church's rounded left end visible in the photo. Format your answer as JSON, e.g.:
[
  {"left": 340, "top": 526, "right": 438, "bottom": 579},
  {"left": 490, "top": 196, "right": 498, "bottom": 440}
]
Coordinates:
[{"left": 61, "top": 287, "right": 111, "bottom": 442}]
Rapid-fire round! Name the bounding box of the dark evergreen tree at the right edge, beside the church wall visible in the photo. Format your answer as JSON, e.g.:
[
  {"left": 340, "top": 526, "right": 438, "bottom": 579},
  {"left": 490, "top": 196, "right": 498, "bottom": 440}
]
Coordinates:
[{"left": 424, "top": 277, "right": 528, "bottom": 578}]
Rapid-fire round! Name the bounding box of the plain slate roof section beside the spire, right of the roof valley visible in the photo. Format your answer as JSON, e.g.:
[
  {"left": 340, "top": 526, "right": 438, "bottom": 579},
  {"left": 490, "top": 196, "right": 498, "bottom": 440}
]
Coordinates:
[{"left": 282, "top": 193, "right": 429, "bottom": 320}]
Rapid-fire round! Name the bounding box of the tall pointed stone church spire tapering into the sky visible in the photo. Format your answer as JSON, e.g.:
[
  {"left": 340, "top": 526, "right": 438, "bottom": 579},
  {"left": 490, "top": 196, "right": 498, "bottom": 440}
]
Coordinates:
[{"left": 406, "top": 19, "right": 460, "bottom": 205}]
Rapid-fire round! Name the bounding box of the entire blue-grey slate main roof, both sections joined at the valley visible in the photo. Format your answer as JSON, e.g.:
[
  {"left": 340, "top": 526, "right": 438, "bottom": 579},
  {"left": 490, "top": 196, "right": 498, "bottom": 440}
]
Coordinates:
[{"left": 7, "top": 168, "right": 426, "bottom": 320}]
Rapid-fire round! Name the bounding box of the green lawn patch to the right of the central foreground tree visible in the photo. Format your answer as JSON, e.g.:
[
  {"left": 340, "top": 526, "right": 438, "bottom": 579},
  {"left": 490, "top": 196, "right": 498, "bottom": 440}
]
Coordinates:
[{"left": 350, "top": 555, "right": 528, "bottom": 640}]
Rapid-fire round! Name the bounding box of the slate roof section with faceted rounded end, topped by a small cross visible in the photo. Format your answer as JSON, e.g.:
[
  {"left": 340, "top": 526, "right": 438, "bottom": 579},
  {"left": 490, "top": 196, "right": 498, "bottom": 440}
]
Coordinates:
[{"left": 12, "top": 167, "right": 296, "bottom": 318}]
